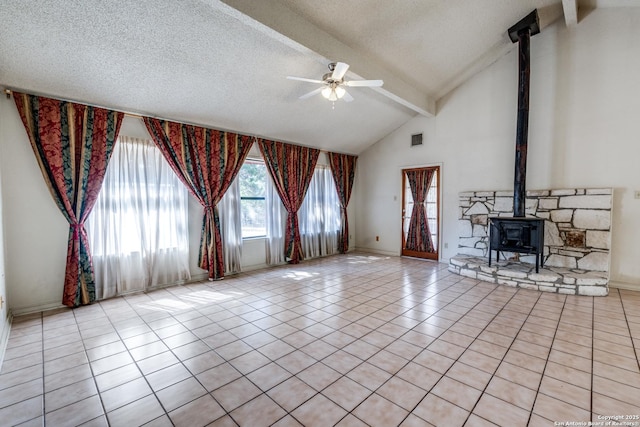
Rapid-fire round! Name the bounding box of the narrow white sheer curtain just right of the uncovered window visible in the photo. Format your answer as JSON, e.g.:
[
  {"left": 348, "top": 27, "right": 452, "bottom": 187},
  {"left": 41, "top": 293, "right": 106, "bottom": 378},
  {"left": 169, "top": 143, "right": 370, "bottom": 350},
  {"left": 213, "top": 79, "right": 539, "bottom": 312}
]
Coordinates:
[{"left": 265, "top": 176, "right": 287, "bottom": 265}]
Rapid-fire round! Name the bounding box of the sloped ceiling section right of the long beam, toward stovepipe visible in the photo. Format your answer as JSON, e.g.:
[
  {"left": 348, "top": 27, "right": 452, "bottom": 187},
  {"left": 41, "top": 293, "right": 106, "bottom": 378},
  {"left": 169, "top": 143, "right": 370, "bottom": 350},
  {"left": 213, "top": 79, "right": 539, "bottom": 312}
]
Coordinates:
[{"left": 282, "top": 0, "right": 562, "bottom": 97}]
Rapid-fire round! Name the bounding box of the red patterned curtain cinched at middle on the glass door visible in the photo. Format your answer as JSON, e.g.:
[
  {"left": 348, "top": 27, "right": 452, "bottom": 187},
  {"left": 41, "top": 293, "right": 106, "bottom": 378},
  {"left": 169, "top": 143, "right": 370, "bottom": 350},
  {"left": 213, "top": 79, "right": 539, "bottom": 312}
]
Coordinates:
[{"left": 405, "top": 169, "right": 435, "bottom": 252}]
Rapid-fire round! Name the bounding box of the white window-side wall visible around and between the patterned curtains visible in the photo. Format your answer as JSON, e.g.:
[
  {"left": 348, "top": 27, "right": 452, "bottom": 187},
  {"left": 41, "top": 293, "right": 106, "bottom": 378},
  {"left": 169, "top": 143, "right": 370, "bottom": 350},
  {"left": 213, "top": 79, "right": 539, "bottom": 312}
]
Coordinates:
[{"left": 0, "top": 106, "right": 355, "bottom": 314}]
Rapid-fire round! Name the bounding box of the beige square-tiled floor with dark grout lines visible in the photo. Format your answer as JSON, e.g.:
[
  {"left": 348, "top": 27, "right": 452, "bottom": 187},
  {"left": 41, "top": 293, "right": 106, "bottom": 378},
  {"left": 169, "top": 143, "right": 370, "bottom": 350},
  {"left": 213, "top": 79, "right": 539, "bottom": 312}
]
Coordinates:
[{"left": 0, "top": 253, "right": 640, "bottom": 427}]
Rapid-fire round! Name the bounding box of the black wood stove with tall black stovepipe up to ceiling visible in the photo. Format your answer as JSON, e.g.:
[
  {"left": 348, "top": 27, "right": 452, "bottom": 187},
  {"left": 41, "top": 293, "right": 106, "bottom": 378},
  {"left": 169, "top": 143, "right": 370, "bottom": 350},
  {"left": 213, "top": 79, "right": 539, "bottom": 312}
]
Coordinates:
[{"left": 489, "top": 10, "right": 544, "bottom": 273}]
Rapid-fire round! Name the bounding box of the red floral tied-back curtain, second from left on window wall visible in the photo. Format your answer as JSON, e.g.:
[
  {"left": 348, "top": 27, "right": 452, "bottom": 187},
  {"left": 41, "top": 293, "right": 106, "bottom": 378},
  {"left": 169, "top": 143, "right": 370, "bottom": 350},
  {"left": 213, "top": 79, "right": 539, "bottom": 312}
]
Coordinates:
[{"left": 144, "top": 117, "right": 253, "bottom": 279}]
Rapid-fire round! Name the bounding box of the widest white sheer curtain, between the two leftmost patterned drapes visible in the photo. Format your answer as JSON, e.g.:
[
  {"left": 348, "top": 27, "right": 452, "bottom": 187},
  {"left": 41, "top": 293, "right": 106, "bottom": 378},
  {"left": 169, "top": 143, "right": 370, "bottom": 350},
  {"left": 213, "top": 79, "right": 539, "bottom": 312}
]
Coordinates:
[{"left": 87, "top": 136, "right": 190, "bottom": 299}]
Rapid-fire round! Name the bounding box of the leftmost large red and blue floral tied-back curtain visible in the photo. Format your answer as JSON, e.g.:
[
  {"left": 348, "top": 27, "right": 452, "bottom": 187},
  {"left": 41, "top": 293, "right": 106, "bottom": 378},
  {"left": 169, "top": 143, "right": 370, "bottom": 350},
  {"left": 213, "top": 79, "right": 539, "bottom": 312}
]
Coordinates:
[{"left": 14, "top": 92, "right": 124, "bottom": 307}]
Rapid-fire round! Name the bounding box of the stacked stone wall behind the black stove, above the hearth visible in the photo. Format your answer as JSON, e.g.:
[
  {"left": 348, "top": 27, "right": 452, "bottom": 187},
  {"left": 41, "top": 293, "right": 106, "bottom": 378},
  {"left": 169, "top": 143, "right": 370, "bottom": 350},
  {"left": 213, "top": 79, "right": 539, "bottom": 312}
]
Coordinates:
[{"left": 458, "top": 188, "right": 613, "bottom": 273}]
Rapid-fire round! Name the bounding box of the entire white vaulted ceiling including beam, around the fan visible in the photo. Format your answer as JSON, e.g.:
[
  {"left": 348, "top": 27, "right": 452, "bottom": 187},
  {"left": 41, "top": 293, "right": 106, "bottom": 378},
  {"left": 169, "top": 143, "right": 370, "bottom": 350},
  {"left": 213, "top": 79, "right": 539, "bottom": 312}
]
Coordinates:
[{"left": 0, "top": 0, "right": 630, "bottom": 154}]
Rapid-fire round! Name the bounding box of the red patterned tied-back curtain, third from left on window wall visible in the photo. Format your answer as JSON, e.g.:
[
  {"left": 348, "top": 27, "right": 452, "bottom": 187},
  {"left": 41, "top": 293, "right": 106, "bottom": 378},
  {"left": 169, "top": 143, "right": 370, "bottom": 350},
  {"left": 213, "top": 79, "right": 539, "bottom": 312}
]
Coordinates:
[{"left": 258, "top": 139, "right": 320, "bottom": 264}]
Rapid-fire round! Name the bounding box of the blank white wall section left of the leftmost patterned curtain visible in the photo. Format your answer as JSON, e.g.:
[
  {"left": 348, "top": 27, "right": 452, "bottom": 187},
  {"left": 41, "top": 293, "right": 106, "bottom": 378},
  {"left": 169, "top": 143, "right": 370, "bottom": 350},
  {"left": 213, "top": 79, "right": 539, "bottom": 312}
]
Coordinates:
[{"left": 0, "top": 97, "right": 69, "bottom": 312}]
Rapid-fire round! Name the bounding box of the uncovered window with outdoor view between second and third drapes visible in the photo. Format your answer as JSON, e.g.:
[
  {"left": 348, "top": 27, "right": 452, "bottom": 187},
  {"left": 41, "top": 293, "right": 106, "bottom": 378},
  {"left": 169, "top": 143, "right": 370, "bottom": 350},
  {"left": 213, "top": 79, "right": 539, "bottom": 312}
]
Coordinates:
[{"left": 238, "top": 159, "right": 267, "bottom": 239}]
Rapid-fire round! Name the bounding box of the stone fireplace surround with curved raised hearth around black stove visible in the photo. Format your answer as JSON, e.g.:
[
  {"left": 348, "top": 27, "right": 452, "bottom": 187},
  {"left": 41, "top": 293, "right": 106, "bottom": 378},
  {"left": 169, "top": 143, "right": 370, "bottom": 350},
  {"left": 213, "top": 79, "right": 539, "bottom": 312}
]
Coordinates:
[{"left": 449, "top": 188, "right": 613, "bottom": 295}]
